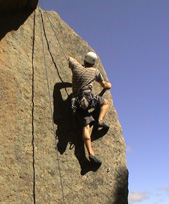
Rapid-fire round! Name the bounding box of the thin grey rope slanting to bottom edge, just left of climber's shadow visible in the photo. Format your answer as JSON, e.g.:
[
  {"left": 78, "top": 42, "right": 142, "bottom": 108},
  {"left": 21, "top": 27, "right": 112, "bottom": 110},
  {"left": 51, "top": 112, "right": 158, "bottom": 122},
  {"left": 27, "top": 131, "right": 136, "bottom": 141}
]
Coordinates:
[{"left": 39, "top": 9, "right": 65, "bottom": 204}]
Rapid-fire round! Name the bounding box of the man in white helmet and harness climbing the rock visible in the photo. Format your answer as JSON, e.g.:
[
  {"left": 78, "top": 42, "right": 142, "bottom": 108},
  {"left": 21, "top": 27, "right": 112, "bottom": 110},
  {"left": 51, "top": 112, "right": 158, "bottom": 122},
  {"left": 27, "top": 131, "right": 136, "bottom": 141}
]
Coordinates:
[{"left": 69, "top": 52, "right": 112, "bottom": 165}]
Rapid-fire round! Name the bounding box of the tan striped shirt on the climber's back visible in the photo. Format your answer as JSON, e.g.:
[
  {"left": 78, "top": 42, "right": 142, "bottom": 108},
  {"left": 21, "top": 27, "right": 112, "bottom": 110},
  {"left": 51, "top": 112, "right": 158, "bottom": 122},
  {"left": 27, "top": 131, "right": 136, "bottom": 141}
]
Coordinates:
[{"left": 69, "top": 57, "right": 103, "bottom": 93}]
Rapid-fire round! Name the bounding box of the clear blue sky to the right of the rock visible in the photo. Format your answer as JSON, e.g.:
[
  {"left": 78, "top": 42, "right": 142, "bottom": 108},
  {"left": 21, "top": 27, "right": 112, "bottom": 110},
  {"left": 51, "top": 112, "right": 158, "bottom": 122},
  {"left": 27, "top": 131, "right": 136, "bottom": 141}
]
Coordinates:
[{"left": 39, "top": 0, "right": 169, "bottom": 204}]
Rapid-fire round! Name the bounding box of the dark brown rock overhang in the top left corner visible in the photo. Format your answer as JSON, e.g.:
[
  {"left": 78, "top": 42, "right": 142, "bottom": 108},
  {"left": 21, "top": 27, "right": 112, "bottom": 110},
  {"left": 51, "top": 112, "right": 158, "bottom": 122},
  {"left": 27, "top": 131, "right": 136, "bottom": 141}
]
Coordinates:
[{"left": 0, "top": 0, "right": 38, "bottom": 12}]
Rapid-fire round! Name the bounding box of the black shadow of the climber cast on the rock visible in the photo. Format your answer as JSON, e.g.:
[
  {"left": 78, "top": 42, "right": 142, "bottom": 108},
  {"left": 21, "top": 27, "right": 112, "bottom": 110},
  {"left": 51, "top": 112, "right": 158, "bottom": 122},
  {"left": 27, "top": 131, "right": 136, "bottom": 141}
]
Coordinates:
[{"left": 53, "top": 83, "right": 104, "bottom": 175}]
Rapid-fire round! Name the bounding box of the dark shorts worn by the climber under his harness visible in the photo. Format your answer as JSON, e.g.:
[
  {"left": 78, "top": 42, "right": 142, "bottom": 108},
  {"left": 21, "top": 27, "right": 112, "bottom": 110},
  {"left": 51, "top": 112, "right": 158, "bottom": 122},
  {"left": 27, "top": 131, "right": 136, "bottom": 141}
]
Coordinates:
[{"left": 76, "top": 92, "right": 104, "bottom": 127}]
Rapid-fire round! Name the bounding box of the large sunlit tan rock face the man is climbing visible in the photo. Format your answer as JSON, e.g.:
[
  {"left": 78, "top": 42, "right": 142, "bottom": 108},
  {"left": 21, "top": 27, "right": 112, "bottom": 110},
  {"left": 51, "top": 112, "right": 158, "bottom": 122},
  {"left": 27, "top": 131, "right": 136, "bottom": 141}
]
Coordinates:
[{"left": 0, "top": 5, "right": 128, "bottom": 204}]
